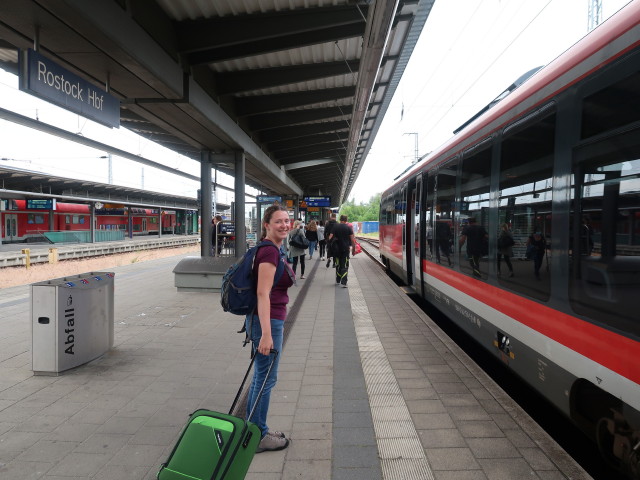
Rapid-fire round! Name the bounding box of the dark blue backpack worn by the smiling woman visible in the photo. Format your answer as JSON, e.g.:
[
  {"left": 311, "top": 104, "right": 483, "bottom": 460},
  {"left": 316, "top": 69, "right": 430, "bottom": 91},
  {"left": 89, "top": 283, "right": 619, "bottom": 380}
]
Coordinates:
[{"left": 220, "top": 240, "right": 285, "bottom": 315}]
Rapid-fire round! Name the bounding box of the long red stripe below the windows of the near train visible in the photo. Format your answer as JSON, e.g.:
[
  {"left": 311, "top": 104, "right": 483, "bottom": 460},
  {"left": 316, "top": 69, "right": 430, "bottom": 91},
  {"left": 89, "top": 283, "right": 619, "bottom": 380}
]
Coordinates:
[{"left": 423, "top": 261, "right": 640, "bottom": 383}]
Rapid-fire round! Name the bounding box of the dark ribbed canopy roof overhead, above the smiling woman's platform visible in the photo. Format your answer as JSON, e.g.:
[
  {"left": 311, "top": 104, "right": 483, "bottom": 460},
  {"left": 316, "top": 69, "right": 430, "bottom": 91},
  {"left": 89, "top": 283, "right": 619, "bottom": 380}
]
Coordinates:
[{"left": 0, "top": 0, "right": 434, "bottom": 206}]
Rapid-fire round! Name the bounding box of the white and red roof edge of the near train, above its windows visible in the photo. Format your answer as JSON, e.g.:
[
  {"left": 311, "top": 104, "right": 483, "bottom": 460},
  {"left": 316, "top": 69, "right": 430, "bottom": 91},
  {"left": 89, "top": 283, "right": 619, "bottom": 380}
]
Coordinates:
[{"left": 385, "top": 2, "right": 640, "bottom": 192}]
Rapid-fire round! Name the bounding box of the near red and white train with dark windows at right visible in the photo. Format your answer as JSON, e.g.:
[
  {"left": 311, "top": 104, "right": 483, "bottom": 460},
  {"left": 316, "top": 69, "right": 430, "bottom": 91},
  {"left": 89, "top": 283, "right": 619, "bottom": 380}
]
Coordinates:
[{"left": 380, "top": 1, "right": 640, "bottom": 479}]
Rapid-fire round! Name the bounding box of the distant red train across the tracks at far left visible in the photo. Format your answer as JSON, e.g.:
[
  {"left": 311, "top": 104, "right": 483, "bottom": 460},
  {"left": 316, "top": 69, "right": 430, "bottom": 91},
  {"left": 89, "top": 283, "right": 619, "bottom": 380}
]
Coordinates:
[{"left": 0, "top": 200, "right": 176, "bottom": 243}]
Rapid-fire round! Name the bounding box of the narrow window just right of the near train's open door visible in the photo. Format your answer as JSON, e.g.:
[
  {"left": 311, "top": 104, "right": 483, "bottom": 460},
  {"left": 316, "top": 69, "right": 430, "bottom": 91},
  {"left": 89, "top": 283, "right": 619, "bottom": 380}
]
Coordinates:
[{"left": 434, "top": 158, "right": 459, "bottom": 266}]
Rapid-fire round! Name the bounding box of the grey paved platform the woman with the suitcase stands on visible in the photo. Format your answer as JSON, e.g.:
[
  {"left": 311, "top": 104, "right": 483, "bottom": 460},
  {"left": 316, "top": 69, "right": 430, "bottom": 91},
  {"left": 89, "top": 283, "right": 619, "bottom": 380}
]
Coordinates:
[{"left": 0, "top": 249, "right": 590, "bottom": 480}]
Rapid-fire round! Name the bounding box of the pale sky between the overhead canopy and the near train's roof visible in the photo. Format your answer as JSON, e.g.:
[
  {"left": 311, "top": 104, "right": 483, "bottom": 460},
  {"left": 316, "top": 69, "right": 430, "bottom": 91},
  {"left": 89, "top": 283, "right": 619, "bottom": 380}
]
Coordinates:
[{"left": 349, "top": 0, "right": 640, "bottom": 203}]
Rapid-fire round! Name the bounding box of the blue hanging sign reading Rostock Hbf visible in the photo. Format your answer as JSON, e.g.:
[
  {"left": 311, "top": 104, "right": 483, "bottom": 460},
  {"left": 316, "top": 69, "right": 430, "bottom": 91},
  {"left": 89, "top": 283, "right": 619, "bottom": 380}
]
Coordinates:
[{"left": 20, "top": 49, "right": 120, "bottom": 127}]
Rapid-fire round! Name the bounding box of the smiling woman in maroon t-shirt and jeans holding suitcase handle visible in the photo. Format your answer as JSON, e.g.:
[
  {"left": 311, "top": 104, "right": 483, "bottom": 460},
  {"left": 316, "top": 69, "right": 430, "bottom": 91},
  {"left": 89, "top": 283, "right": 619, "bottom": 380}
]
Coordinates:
[{"left": 245, "top": 205, "right": 295, "bottom": 453}]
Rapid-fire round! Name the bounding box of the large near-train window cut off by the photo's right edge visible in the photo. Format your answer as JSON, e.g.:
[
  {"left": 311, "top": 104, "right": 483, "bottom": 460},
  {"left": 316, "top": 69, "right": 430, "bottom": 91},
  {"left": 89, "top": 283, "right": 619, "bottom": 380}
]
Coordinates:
[{"left": 568, "top": 128, "right": 640, "bottom": 337}]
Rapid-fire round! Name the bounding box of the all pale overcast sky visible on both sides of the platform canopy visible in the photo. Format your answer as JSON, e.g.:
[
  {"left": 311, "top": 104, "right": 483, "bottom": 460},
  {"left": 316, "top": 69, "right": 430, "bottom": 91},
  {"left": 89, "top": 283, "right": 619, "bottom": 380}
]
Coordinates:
[{"left": 0, "top": 0, "right": 640, "bottom": 203}]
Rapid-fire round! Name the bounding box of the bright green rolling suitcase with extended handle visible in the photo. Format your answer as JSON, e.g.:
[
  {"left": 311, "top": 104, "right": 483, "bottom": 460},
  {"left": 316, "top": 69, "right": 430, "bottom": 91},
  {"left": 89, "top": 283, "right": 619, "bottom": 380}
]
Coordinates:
[{"left": 157, "top": 350, "right": 278, "bottom": 480}]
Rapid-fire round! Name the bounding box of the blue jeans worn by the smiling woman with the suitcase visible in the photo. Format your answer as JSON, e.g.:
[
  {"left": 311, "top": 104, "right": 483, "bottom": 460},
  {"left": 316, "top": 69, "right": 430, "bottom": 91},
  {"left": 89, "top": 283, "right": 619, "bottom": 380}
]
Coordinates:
[{"left": 245, "top": 315, "right": 284, "bottom": 437}]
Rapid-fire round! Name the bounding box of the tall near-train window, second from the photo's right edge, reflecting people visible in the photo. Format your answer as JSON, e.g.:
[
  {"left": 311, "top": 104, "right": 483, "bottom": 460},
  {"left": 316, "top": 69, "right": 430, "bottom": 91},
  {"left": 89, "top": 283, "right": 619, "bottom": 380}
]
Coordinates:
[{"left": 492, "top": 110, "right": 556, "bottom": 301}]
